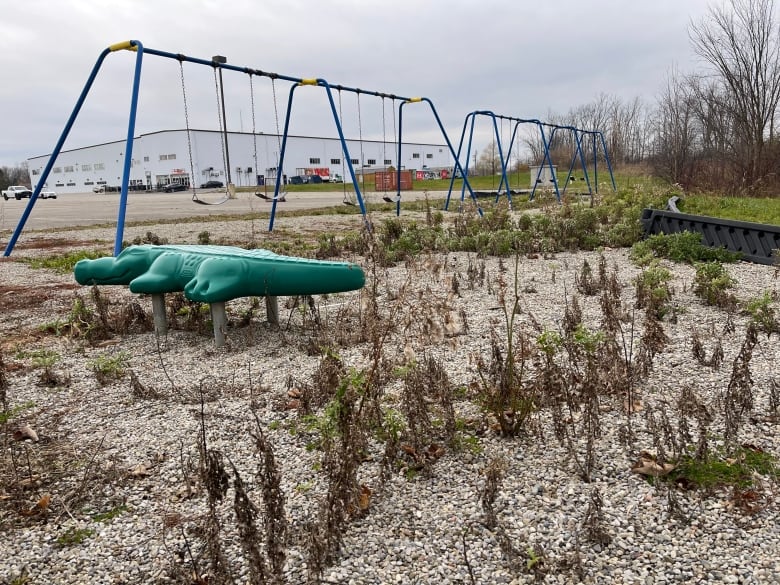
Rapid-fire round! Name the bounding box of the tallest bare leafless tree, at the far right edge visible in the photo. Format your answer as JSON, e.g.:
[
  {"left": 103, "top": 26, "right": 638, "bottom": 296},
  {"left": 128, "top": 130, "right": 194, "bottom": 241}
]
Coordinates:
[{"left": 689, "top": 0, "right": 780, "bottom": 190}]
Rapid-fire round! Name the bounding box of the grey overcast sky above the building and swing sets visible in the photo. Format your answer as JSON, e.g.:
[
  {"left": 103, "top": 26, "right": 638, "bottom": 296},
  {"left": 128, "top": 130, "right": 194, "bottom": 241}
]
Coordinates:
[{"left": 0, "top": 0, "right": 711, "bottom": 165}]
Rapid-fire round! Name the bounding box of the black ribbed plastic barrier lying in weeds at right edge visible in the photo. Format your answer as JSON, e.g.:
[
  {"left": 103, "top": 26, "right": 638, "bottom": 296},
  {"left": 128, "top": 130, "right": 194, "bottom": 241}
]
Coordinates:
[{"left": 641, "top": 209, "right": 780, "bottom": 264}]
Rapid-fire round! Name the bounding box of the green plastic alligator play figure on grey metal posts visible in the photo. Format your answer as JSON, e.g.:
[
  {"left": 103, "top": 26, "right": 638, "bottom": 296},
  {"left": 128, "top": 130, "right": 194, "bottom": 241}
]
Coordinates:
[{"left": 74, "top": 245, "right": 365, "bottom": 347}]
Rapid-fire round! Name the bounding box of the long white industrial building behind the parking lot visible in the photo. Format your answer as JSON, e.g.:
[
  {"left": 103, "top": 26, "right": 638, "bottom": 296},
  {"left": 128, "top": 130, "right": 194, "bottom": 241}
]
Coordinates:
[{"left": 28, "top": 130, "right": 454, "bottom": 193}]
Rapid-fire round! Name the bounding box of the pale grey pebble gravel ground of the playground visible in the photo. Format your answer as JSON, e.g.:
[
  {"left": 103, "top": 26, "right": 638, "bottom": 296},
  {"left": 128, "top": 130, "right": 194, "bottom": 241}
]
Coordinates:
[{"left": 0, "top": 212, "right": 780, "bottom": 584}]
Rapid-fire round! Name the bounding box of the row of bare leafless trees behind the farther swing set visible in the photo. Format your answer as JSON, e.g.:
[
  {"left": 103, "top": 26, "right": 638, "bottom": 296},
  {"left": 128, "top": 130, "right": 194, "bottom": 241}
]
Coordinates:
[{"left": 476, "top": 0, "right": 780, "bottom": 195}]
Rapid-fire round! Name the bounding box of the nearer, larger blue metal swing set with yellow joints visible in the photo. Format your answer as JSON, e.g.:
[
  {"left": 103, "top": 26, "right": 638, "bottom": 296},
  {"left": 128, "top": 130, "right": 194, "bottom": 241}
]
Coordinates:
[{"left": 3, "top": 40, "right": 470, "bottom": 256}]
